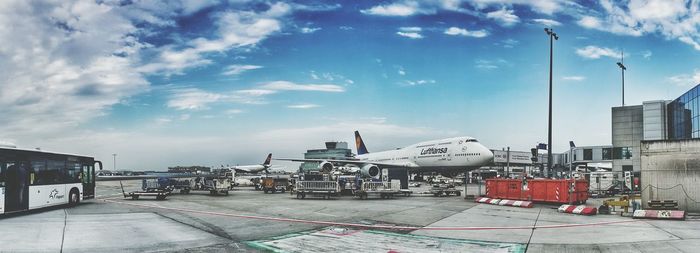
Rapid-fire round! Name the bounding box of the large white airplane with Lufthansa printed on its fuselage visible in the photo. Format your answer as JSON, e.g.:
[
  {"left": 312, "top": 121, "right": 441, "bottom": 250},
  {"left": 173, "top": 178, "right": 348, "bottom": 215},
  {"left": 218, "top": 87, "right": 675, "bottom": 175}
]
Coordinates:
[{"left": 275, "top": 131, "right": 493, "bottom": 177}]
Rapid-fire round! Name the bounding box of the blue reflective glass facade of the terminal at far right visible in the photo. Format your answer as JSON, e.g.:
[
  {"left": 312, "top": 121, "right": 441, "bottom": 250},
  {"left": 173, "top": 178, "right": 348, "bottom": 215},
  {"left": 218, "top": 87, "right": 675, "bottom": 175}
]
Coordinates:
[{"left": 666, "top": 85, "right": 700, "bottom": 140}]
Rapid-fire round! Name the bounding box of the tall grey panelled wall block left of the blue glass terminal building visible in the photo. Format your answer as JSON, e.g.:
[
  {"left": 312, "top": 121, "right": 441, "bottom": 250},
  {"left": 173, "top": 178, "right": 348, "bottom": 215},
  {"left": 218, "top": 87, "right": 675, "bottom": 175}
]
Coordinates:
[{"left": 612, "top": 105, "right": 644, "bottom": 172}]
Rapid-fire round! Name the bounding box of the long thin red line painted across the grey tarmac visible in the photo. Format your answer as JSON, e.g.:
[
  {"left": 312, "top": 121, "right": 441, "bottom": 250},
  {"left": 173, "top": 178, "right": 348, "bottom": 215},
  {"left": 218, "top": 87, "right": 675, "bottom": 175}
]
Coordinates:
[{"left": 102, "top": 199, "right": 640, "bottom": 231}]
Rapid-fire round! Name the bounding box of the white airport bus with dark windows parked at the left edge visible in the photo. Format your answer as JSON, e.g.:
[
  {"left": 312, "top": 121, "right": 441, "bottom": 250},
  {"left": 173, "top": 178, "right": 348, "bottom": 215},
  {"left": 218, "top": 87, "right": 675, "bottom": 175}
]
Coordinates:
[{"left": 0, "top": 147, "right": 102, "bottom": 214}]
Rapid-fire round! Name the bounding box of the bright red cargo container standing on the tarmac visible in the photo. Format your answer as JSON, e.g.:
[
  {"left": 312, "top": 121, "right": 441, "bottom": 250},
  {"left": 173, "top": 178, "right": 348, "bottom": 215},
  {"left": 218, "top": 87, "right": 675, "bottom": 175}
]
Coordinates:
[{"left": 486, "top": 178, "right": 588, "bottom": 204}]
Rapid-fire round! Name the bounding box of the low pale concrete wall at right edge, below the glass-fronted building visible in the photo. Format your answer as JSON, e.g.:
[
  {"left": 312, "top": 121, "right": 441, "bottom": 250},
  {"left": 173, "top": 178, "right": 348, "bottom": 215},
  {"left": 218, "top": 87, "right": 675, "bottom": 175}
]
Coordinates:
[{"left": 641, "top": 139, "right": 700, "bottom": 212}]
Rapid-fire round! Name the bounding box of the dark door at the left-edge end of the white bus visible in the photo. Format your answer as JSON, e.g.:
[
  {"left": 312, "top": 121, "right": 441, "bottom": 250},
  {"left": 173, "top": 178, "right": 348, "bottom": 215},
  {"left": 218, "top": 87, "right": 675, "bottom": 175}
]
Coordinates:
[{"left": 0, "top": 161, "right": 29, "bottom": 212}]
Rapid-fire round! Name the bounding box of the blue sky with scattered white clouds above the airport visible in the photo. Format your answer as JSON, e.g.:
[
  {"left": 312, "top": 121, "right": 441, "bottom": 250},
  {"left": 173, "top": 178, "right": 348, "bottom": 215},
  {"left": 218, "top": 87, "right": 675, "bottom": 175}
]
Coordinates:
[{"left": 0, "top": 0, "right": 700, "bottom": 169}]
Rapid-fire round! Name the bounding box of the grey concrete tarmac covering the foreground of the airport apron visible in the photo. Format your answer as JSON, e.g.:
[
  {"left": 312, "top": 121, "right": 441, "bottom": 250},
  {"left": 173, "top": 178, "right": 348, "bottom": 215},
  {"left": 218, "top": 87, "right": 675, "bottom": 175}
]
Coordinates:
[{"left": 0, "top": 181, "right": 700, "bottom": 252}]
